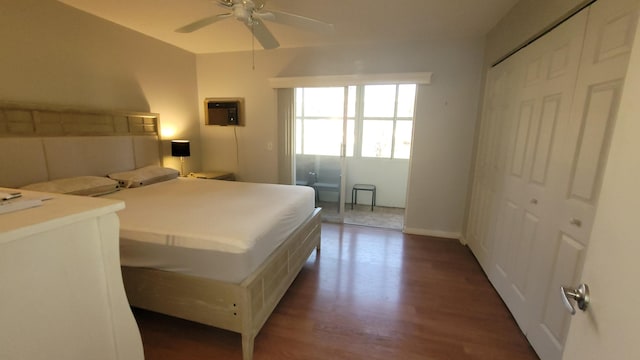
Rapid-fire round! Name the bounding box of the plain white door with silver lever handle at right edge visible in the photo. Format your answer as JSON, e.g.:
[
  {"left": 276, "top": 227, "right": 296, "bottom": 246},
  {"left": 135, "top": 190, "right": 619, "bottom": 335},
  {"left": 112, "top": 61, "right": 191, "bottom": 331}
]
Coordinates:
[{"left": 563, "top": 12, "right": 640, "bottom": 359}]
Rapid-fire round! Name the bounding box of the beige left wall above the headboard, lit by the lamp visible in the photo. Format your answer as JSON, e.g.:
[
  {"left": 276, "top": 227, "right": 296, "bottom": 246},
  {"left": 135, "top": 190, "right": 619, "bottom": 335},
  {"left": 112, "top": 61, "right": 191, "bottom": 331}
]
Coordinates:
[{"left": 0, "top": 0, "right": 200, "bottom": 173}]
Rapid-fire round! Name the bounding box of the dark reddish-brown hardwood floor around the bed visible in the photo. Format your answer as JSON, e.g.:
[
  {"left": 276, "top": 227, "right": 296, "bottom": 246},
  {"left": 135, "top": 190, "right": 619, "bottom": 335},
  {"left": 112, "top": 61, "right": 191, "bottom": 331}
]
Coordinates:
[{"left": 134, "top": 224, "right": 538, "bottom": 360}]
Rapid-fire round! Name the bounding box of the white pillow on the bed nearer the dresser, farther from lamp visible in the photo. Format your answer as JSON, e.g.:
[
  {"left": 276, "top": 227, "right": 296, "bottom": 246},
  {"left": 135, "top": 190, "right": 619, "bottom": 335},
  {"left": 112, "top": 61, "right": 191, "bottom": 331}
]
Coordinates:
[{"left": 22, "top": 176, "right": 120, "bottom": 196}]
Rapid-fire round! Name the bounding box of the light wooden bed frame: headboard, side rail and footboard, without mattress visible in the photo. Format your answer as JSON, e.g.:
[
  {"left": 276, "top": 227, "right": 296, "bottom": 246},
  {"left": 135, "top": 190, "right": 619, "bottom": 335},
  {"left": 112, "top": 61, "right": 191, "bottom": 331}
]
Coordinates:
[{"left": 0, "top": 103, "right": 321, "bottom": 360}]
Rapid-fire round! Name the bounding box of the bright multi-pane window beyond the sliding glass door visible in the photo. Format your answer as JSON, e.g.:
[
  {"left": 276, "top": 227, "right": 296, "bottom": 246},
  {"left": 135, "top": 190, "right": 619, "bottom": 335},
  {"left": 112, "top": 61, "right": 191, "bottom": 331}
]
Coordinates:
[{"left": 295, "top": 84, "right": 416, "bottom": 159}]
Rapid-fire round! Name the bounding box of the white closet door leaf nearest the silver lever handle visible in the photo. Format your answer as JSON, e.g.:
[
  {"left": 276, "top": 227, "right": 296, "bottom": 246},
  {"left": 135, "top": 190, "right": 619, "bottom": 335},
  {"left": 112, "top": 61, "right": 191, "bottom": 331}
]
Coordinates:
[{"left": 528, "top": 0, "right": 638, "bottom": 359}]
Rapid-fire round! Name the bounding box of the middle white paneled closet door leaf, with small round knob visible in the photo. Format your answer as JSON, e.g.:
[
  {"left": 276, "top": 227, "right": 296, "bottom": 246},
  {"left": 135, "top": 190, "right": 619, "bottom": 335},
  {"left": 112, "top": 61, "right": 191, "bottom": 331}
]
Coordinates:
[{"left": 489, "top": 8, "right": 587, "bottom": 332}]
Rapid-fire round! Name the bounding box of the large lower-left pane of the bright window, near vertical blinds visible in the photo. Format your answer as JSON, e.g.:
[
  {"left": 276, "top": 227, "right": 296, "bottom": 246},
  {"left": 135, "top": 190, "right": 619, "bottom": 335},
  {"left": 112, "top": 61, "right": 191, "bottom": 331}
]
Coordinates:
[{"left": 303, "top": 119, "right": 342, "bottom": 156}]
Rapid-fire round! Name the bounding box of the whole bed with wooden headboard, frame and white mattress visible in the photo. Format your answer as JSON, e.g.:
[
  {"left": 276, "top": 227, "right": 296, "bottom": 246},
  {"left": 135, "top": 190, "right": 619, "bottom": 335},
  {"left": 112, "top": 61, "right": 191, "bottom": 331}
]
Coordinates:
[{"left": 0, "top": 103, "right": 321, "bottom": 360}]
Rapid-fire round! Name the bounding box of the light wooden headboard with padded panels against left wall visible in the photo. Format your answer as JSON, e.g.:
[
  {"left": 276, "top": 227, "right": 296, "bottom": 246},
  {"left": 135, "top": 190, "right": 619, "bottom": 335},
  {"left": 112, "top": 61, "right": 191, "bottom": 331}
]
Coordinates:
[{"left": 0, "top": 102, "right": 162, "bottom": 187}]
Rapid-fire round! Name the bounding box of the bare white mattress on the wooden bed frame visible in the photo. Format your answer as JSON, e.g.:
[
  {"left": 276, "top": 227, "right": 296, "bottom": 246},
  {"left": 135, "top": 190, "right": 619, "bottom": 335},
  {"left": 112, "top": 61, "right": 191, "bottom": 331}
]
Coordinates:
[{"left": 107, "top": 178, "right": 315, "bottom": 283}]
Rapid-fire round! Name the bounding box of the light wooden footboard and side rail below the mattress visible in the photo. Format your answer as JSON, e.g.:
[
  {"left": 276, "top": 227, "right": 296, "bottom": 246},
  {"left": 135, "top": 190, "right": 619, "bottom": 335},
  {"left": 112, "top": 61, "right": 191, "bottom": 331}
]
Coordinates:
[{"left": 122, "top": 208, "right": 321, "bottom": 360}]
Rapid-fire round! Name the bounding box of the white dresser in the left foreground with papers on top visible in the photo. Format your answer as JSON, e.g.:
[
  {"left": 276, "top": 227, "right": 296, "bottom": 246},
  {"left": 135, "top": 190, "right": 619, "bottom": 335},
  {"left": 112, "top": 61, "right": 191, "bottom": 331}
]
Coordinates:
[{"left": 0, "top": 188, "right": 144, "bottom": 360}]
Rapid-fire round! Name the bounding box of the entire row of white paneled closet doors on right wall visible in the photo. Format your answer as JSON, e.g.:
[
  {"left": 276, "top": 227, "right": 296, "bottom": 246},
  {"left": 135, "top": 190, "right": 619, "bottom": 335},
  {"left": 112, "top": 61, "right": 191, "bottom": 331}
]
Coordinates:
[{"left": 467, "top": 0, "right": 638, "bottom": 360}]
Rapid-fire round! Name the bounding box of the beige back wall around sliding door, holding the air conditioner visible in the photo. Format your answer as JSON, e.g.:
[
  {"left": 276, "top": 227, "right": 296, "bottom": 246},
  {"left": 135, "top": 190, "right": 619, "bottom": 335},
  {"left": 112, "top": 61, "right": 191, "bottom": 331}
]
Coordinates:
[{"left": 197, "top": 39, "right": 484, "bottom": 237}]
